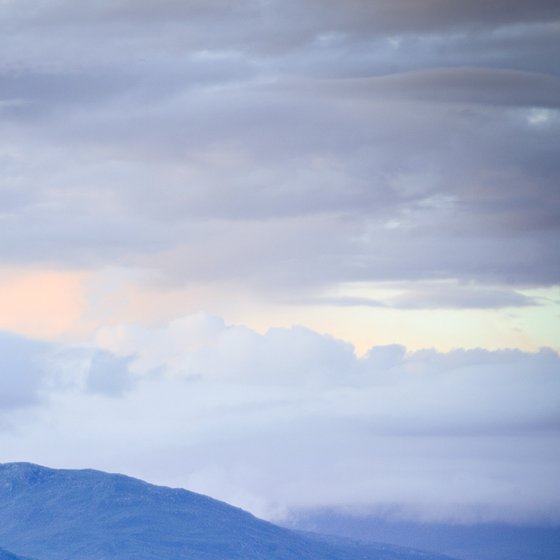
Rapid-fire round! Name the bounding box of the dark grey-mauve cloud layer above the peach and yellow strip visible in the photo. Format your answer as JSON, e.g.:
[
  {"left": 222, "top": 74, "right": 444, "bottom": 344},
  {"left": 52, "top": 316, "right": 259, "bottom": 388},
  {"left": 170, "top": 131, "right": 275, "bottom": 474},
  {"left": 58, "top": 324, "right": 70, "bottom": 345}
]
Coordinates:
[{"left": 0, "top": 0, "right": 560, "bottom": 307}]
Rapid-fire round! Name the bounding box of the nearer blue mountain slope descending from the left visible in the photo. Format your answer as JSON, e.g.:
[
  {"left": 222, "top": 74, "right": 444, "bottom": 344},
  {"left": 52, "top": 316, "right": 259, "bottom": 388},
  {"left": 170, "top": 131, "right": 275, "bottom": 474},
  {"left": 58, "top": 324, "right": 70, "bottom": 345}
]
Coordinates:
[{"left": 0, "top": 463, "right": 456, "bottom": 560}]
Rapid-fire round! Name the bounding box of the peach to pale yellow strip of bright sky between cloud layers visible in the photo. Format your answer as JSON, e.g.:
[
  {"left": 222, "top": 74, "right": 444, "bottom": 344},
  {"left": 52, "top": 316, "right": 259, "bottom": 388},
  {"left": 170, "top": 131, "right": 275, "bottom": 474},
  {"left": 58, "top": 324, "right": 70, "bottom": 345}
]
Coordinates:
[{"left": 0, "top": 269, "right": 560, "bottom": 354}]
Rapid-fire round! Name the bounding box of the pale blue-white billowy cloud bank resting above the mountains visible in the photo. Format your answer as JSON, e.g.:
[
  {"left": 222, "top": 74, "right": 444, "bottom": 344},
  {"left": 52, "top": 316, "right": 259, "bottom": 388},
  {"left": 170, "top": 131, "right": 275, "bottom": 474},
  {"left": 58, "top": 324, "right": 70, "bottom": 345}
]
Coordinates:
[{"left": 0, "top": 314, "right": 560, "bottom": 522}]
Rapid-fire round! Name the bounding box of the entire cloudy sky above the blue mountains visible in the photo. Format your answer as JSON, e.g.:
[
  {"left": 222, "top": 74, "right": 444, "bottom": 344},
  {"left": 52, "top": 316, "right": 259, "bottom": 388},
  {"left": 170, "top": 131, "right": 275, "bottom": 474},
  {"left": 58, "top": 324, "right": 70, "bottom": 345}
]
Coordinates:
[{"left": 0, "top": 0, "right": 560, "bottom": 523}]
